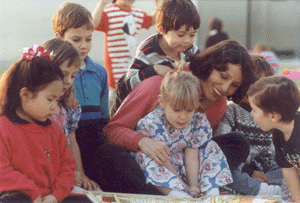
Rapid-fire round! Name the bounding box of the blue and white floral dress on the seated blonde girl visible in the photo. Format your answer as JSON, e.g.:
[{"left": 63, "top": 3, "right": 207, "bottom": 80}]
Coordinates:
[{"left": 133, "top": 107, "right": 233, "bottom": 196}]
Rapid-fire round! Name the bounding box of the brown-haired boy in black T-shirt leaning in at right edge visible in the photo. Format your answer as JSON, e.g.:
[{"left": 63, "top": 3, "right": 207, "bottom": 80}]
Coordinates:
[{"left": 248, "top": 76, "right": 300, "bottom": 202}]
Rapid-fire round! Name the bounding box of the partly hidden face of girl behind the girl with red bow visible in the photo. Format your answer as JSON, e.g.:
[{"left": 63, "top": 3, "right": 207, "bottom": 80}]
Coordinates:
[{"left": 60, "top": 60, "right": 79, "bottom": 93}]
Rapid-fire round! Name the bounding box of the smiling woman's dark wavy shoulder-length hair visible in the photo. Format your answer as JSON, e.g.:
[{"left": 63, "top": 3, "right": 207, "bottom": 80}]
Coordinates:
[{"left": 190, "top": 40, "right": 257, "bottom": 103}]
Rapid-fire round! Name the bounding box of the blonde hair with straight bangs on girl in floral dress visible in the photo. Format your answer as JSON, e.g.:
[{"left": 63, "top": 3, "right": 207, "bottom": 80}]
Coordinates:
[{"left": 160, "top": 71, "right": 200, "bottom": 111}]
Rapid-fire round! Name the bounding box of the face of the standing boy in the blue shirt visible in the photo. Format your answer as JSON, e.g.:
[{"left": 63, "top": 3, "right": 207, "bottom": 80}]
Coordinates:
[{"left": 62, "top": 26, "right": 93, "bottom": 61}]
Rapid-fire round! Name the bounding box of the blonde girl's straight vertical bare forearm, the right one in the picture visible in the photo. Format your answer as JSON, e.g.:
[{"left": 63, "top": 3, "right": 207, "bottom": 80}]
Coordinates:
[{"left": 184, "top": 147, "right": 200, "bottom": 194}]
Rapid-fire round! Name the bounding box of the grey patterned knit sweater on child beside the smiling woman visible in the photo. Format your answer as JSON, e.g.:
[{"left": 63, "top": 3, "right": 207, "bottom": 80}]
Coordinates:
[{"left": 214, "top": 103, "right": 276, "bottom": 176}]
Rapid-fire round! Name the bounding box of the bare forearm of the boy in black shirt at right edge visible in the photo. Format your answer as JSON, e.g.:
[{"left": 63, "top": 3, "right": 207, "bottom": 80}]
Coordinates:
[{"left": 282, "top": 167, "right": 300, "bottom": 202}]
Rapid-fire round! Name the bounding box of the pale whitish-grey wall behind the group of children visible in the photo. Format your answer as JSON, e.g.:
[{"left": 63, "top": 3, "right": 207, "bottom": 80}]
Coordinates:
[{"left": 0, "top": 0, "right": 299, "bottom": 66}]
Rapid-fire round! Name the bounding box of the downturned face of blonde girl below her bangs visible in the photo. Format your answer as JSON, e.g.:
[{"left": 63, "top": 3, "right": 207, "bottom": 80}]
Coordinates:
[{"left": 161, "top": 103, "right": 195, "bottom": 129}]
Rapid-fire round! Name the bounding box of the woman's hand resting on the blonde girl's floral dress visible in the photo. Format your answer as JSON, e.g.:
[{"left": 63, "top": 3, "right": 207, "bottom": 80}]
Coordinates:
[{"left": 138, "top": 137, "right": 170, "bottom": 165}]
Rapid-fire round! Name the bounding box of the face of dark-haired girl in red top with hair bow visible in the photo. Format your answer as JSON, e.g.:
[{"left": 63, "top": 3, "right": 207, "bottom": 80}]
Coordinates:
[{"left": 22, "top": 80, "right": 63, "bottom": 123}]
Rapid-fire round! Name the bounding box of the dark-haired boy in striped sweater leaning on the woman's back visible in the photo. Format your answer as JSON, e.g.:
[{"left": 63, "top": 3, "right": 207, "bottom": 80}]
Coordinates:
[{"left": 111, "top": 0, "right": 200, "bottom": 116}]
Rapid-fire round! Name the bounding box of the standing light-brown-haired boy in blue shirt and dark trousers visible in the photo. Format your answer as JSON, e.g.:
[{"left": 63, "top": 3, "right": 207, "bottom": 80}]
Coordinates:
[{"left": 52, "top": 2, "right": 109, "bottom": 179}]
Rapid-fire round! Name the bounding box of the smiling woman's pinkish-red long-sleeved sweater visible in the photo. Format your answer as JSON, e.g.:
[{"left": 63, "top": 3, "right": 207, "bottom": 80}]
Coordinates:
[{"left": 103, "top": 75, "right": 227, "bottom": 151}]
